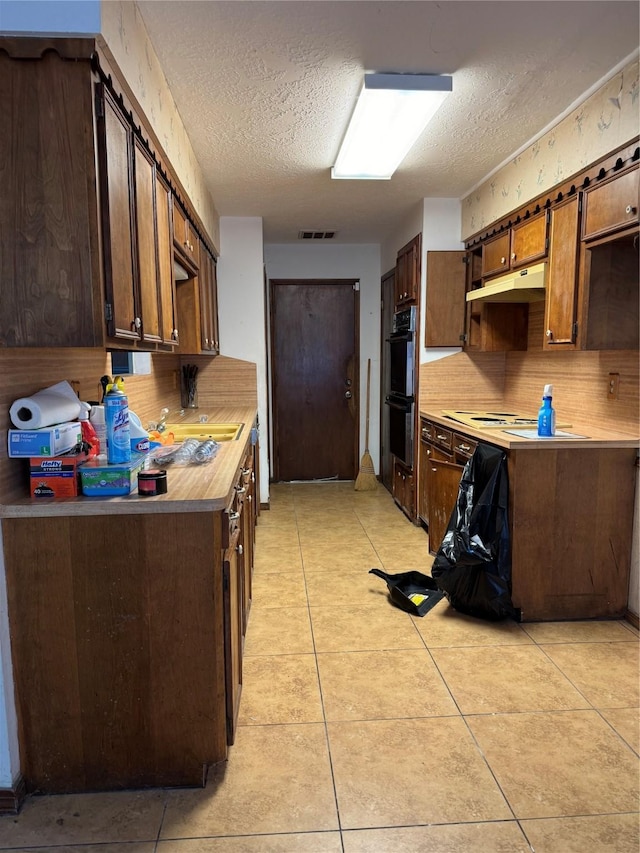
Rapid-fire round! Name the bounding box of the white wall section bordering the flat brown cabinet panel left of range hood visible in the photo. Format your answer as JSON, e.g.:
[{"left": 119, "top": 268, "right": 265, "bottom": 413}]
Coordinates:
[{"left": 420, "top": 198, "right": 464, "bottom": 364}]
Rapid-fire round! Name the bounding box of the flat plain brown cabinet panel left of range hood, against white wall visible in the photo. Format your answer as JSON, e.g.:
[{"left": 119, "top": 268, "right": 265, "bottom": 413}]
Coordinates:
[{"left": 425, "top": 252, "right": 467, "bottom": 347}]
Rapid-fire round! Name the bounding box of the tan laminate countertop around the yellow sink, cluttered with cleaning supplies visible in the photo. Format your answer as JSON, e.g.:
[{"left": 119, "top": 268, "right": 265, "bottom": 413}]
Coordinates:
[{"left": 0, "top": 406, "right": 257, "bottom": 518}]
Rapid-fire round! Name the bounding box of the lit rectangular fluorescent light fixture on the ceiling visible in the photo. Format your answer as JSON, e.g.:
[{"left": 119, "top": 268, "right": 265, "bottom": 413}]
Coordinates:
[{"left": 331, "top": 74, "right": 452, "bottom": 180}]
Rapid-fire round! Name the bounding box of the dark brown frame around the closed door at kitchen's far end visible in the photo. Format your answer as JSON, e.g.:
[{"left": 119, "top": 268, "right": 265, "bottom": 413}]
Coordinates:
[{"left": 266, "top": 276, "right": 361, "bottom": 483}]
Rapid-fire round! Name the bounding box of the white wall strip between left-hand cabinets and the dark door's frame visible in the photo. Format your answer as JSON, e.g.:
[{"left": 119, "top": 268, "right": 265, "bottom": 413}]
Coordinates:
[{"left": 217, "top": 216, "right": 269, "bottom": 503}]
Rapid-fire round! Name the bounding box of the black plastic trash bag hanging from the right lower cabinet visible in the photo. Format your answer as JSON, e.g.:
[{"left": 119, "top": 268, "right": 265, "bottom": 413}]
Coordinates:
[{"left": 431, "top": 443, "right": 518, "bottom": 620}]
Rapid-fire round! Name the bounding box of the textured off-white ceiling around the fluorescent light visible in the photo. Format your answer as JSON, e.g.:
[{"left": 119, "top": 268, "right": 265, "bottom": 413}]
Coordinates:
[{"left": 137, "top": 0, "right": 640, "bottom": 243}]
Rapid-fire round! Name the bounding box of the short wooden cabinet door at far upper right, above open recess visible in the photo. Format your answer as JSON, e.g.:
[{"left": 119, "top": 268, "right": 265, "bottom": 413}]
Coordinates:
[{"left": 582, "top": 166, "right": 640, "bottom": 240}]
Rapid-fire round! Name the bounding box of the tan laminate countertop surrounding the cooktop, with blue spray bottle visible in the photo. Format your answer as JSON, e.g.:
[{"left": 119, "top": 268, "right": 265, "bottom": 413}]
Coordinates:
[{"left": 420, "top": 409, "right": 640, "bottom": 450}]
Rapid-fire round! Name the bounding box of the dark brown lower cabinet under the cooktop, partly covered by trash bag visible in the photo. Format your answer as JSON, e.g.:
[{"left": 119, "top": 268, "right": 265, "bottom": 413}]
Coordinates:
[{"left": 418, "top": 418, "right": 636, "bottom": 622}]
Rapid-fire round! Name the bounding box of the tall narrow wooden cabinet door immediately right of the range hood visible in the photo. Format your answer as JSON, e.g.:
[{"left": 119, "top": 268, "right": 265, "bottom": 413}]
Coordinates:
[{"left": 543, "top": 195, "right": 580, "bottom": 349}]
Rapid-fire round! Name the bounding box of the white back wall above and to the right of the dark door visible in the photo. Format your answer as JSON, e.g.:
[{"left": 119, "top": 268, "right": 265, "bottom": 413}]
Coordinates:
[{"left": 264, "top": 244, "right": 382, "bottom": 473}]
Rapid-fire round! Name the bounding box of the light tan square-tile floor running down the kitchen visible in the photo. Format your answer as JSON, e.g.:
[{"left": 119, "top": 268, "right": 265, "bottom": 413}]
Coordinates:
[{"left": 0, "top": 483, "right": 640, "bottom": 853}]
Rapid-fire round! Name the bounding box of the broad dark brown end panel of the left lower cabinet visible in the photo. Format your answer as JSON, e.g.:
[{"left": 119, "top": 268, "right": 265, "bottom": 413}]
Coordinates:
[{"left": 2, "top": 512, "right": 227, "bottom": 793}]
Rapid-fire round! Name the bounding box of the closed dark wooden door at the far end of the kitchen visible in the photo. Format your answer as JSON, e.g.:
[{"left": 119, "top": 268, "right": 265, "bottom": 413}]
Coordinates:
[{"left": 270, "top": 279, "right": 359, "bottom": 481}]
